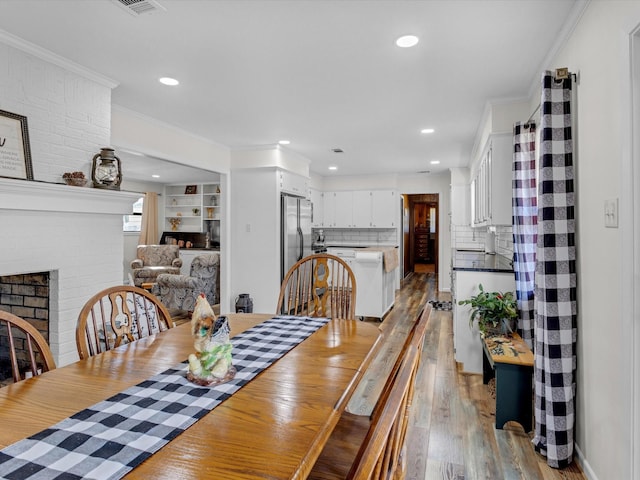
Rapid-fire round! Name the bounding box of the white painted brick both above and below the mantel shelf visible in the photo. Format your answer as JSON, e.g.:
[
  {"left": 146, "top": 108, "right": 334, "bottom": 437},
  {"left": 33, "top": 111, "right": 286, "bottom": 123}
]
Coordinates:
[{"left": 0, "top": 43, "right": 130, "bottom": 366}]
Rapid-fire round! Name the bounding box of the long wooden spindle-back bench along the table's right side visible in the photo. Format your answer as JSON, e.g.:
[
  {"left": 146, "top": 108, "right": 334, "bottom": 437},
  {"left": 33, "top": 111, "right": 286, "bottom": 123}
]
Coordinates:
[{"left": 307, "top": 305, "right": 431, "bottom": 480}]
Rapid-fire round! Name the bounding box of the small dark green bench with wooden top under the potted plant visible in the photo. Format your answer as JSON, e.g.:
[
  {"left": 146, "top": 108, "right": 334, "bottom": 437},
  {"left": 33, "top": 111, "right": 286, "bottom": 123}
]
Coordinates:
[{"left": 482, "top": 333, "right": 533, "bottom": 432}]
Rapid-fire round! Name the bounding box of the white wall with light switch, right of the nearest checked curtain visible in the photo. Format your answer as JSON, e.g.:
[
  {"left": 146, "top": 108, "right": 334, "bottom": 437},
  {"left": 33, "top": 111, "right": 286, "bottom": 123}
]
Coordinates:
[{"left": 545, "top": 1, "right": 640, "bottom": 480}]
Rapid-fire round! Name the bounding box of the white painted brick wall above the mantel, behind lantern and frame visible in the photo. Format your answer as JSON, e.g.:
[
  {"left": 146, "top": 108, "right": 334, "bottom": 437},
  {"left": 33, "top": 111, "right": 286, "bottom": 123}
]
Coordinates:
[{"left": 0, "top": 43, "right": 111, "bottom": 182}]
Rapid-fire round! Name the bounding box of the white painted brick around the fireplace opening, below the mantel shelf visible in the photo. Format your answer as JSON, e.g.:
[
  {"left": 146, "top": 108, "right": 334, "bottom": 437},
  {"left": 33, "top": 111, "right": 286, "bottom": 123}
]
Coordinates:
[{"left": 0, "top": 209, "right": 124, "bottom": 365}]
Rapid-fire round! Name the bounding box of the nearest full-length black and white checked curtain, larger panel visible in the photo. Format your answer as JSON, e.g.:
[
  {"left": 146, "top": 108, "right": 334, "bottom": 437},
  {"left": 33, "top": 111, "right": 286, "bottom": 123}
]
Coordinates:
[{"left": 533, "top": 72, "right": 576, "bottom": 468}]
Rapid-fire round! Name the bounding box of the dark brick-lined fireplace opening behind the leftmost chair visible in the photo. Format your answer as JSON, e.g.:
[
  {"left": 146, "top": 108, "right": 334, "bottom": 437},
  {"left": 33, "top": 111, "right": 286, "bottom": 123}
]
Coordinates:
[{"left": 0, "top": 272, "right": 50, "bottom": 386}]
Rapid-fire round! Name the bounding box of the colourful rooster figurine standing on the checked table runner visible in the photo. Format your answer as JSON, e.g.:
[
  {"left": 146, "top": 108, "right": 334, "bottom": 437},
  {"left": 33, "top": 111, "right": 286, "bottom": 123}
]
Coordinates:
[{"left": 187, "top": 293, "right": 236, "bottom": 385}]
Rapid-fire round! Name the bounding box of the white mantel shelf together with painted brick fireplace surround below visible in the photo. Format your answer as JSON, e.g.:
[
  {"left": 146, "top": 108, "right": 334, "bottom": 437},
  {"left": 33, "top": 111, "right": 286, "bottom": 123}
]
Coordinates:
[{"left": 0, "top": 178, "right": 140, "bottom": 366}]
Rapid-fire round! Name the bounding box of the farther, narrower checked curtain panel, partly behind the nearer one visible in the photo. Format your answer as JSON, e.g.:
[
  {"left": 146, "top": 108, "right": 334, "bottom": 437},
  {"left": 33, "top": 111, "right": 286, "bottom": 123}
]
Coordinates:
[{"left": 511, "top": 123, "right": 538, "bottom": 348}]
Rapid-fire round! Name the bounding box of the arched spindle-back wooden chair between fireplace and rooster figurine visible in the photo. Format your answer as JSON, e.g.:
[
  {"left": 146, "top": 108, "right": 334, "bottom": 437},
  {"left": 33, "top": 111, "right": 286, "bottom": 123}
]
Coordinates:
[{"left": 76, "top": 285, "right": 174, "bottom": 360}]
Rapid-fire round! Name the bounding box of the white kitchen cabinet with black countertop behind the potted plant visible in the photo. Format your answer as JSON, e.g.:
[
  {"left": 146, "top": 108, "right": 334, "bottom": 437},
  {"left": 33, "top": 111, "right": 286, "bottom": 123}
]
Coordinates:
[{"left": 451, "top": 249, "right": 515, "bottom": 373}]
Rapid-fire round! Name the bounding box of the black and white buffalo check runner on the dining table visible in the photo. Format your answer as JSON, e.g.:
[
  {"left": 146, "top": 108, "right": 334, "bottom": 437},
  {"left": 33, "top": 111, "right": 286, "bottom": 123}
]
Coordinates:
[{"left": 0, "top": 315, "right": 329, "bottom": 480}]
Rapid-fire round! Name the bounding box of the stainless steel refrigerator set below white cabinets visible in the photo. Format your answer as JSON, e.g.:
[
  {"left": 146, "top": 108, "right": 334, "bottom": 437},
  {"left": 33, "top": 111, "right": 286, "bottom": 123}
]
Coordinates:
[{"left": 280, "top": 194, "right": 311, "bottom": 280}]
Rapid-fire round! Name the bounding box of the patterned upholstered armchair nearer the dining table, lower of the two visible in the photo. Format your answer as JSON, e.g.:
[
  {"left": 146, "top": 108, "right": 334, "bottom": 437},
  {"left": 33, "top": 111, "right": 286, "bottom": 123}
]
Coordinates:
[{"left": 152, "top": 253, "right": 220, "bottom": 312}]
